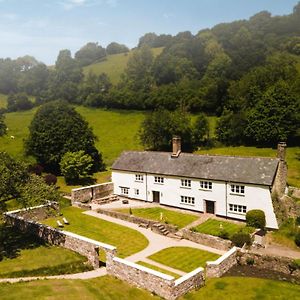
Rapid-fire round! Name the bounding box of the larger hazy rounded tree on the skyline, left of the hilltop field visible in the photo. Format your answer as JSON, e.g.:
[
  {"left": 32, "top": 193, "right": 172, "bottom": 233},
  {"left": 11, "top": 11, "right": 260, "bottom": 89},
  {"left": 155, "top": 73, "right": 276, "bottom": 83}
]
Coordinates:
[{"left": 75, "top": 43, "right": 106, "bottom": 67}]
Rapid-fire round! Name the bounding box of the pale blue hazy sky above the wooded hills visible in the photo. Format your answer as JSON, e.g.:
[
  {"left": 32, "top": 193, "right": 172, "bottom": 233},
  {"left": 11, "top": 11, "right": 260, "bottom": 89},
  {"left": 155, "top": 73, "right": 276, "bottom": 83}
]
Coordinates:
[{"left": 0, "top": 0, "right": 299, "bottom": 65}]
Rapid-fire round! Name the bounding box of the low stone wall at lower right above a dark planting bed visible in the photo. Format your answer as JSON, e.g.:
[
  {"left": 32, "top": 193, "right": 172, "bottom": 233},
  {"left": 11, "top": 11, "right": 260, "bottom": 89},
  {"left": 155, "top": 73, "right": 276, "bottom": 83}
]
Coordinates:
[{"left": 236, "top": 250, "right": 300, "bottom": 283}]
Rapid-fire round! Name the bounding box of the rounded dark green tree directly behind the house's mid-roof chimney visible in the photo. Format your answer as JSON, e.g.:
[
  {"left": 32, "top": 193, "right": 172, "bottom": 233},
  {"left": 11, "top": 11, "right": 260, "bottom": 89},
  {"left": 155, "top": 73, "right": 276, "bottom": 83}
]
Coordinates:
[{"left": 139, "top": 109, "right": 194, "bottom": 151}]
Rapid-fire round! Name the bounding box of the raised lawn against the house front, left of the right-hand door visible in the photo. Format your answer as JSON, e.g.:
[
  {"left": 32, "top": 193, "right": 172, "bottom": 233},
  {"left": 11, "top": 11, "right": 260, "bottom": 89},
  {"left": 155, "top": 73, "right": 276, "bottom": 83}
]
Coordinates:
[{"left": 118, "top": 207, "right": 198, "bottom": 228}]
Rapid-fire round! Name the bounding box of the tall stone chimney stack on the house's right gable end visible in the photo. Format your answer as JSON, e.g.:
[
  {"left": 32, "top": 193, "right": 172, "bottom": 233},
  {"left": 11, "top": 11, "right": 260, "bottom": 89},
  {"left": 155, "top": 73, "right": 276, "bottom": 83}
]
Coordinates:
[{"left": 272, "top": 142, "right": 287, "bottom": 197}]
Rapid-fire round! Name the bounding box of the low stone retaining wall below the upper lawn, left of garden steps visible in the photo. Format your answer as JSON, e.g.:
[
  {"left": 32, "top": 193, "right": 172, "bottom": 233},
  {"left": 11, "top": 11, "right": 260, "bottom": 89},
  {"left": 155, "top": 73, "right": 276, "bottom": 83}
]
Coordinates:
[{"left": 97, "top": 208, "right": 178, "bottom": 233}]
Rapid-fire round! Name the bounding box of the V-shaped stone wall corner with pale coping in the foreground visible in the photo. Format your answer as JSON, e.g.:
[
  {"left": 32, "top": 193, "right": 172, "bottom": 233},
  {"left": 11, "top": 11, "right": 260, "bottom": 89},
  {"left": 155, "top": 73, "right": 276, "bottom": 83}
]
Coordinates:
[{"left": 106, "top": 257, "right": 205, "bottom": 300}]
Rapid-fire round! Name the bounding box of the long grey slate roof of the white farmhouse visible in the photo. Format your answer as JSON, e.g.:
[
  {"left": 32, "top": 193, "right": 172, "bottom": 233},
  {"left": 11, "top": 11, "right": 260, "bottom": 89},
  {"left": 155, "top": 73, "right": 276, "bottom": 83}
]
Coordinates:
[{"left": 112, "top": 151, "right": 279, "bottom": 186}]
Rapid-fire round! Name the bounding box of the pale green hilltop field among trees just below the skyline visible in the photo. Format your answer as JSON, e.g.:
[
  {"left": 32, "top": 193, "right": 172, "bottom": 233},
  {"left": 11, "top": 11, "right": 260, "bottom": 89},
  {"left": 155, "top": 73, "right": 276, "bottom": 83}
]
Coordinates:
[{"left": 83, "top": 48, "right": 163, "bottom": 84}]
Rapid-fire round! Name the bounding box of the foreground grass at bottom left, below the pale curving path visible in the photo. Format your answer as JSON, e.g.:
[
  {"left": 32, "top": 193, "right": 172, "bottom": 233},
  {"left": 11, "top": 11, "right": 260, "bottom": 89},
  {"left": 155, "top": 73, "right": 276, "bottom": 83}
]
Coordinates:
[{"left": 0, "top": 276, "right": 159, "bottom": 300}]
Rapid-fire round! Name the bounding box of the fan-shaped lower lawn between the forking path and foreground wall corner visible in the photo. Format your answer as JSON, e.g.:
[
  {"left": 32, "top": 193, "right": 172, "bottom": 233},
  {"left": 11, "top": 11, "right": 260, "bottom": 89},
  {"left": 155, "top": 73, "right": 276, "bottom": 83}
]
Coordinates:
[{"left": 148, "top": 247, "right": 220, "bottom": 273}]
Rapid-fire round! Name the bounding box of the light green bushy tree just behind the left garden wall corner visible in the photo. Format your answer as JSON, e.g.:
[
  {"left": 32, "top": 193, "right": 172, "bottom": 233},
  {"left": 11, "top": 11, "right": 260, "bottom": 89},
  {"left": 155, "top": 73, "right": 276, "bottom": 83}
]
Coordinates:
[{"left": 17, "top": 174, "right": 60, "bottom": 208}]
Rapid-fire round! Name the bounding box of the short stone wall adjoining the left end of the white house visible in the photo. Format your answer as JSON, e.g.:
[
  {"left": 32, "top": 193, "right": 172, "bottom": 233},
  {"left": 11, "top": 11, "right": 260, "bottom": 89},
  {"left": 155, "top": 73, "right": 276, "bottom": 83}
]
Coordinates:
[{"left": 71, "top": 182, "right": 114, "bottom": 203}]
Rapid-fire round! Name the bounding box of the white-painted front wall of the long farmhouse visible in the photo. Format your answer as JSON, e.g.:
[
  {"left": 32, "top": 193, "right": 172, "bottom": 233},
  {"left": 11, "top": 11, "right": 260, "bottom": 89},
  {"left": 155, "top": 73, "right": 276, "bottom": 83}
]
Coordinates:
[{"left": 112, "top": 171, "right": 278, "bottom": 229}]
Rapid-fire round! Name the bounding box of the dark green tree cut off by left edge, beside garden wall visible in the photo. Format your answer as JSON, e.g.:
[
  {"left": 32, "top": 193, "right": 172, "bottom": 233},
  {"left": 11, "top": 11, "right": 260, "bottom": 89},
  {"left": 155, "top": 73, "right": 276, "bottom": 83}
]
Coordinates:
[{"left": 0, "top": 152, "right": 28, "bottom": 201}]
